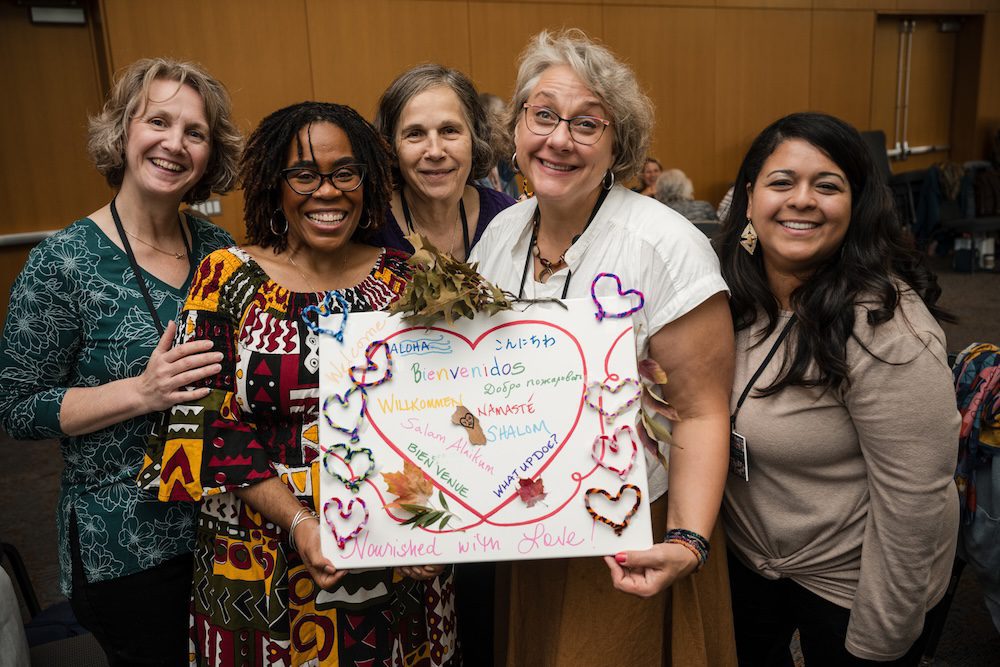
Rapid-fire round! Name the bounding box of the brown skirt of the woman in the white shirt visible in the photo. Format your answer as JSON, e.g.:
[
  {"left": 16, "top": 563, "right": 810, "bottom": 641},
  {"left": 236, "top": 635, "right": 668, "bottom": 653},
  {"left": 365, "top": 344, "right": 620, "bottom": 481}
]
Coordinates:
[{"left": 496, "top": 498, "right": 736, "bottom": 667}]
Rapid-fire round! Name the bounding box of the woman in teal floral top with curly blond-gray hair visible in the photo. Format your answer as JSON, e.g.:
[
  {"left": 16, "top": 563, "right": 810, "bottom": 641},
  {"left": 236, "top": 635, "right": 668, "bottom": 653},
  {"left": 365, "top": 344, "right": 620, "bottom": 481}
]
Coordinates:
[{"left": 0, "top": 58, "right": 242, "bottom": 665}]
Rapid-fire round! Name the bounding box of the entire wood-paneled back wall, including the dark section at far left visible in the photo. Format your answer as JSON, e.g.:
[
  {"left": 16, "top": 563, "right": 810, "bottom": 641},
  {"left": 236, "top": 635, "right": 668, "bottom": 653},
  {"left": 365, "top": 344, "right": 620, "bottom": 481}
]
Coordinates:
[{"left": 0, "top": 0, "right": 1000, "bottom": 268}]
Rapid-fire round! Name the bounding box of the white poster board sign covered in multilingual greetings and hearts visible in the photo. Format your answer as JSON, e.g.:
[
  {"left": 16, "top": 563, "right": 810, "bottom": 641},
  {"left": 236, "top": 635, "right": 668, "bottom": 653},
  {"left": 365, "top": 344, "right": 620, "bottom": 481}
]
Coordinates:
[{"left": 318, "top": 299, "right": 651, "bottom": 568}]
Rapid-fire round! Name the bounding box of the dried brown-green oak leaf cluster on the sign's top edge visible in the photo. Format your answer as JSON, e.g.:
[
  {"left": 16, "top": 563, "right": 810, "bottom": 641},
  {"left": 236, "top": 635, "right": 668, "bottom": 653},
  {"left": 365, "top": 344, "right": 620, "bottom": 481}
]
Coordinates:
[{"left": 389, "top": 234, "right": 511, "bottom": 326}]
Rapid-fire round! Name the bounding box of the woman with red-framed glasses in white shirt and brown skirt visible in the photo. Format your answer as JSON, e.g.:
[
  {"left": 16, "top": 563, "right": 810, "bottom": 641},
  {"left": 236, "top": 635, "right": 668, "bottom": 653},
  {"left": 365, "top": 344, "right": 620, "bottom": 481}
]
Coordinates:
[{"left": 470, "top": 30, "right": 734, "bottom": 667}]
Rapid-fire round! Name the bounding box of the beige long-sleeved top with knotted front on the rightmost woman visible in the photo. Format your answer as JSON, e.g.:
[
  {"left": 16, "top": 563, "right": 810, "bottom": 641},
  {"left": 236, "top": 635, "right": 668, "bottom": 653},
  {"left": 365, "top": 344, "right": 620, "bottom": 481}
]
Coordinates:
[{"left": 723, "top": 292, "right": 959, "bottom": 660}]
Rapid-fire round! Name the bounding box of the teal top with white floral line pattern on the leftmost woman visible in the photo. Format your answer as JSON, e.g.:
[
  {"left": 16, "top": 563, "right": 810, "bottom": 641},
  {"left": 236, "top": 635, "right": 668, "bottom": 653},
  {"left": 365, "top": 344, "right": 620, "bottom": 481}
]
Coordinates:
[{"left": 0, "top": 216, "right": 233, "bottom": 597}]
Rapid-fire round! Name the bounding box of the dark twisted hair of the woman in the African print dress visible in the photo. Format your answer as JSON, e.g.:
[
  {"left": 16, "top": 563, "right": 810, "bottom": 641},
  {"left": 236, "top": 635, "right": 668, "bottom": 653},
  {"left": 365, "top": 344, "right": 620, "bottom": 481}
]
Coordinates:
[{"left": 239, "top": 102, "right": 392, "bottom": 252}]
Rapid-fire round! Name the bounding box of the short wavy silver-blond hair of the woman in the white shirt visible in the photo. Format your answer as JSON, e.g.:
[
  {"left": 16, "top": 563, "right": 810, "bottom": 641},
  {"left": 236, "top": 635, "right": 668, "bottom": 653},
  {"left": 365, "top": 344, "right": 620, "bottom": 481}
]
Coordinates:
[{"left": 507, "top": 28, "right": 653, "bottom": 181}]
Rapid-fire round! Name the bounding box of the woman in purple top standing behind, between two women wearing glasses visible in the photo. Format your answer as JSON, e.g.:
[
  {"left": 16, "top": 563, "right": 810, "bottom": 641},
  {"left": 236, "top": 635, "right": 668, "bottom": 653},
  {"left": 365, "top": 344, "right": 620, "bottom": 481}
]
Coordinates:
[{"left": 373, "top": 64, "right": 514, "bottom": 260}]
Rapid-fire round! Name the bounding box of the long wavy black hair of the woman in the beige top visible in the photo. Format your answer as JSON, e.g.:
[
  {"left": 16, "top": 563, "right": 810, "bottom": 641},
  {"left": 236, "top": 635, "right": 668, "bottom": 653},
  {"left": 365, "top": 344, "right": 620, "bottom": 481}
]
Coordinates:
[{"left": 716, "top": 113, "right": 955, "bottom": 396}]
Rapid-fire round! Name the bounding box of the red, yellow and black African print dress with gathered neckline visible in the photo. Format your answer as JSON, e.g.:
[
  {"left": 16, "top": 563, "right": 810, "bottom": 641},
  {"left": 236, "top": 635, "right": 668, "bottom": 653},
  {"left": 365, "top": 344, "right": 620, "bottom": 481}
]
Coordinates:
[{"left": 139, "top": 248, "right": 458, "bottom": 667}]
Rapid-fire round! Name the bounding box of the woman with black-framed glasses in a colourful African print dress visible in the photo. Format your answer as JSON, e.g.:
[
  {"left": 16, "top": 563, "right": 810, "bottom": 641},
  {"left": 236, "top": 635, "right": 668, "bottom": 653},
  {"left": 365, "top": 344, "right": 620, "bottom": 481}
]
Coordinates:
[{"left": 139, "top": 102, "right": 457, "bottom": 667}]
